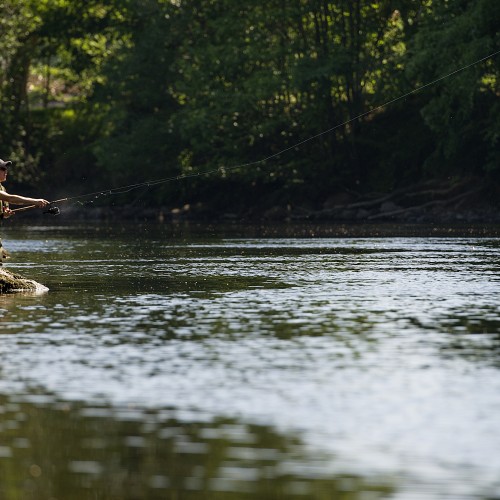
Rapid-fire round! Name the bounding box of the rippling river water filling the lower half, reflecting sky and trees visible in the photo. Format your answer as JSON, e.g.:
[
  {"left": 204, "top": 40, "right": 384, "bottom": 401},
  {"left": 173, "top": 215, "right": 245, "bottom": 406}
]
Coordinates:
[{"left": 0, "top": 224, "right": 500, "bottom": 500}]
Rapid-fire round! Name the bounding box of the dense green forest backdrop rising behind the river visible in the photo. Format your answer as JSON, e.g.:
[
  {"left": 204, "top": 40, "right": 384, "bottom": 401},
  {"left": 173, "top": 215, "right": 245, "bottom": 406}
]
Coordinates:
[{"left": 0, "top": 0, "right": 500, "bottom": 218}]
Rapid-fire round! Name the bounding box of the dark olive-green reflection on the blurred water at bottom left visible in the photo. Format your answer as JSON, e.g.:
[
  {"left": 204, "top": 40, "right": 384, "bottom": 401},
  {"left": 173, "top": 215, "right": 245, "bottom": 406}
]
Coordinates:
[{"left": 0, "top": 391, "right": 391, "bottom": 500}]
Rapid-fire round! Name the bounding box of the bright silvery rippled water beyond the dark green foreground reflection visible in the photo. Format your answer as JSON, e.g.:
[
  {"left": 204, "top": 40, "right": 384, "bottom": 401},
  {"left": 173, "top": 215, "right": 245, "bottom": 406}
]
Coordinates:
[{"left": 0, "top": 225, "right": 500, "bottom": 498}]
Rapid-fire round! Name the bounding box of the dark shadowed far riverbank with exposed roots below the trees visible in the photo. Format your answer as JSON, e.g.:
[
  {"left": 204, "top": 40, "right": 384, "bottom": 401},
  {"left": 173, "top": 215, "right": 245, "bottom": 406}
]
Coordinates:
[{"left": 40, "top": 178, "right": 500, "bottom": 225}]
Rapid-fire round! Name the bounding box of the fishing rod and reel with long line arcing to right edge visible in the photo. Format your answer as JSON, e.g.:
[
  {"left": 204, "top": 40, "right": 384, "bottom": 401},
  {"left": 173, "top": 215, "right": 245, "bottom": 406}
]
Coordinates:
[{"left": 7, "top": 50, "right": 500, "bottom": 215}]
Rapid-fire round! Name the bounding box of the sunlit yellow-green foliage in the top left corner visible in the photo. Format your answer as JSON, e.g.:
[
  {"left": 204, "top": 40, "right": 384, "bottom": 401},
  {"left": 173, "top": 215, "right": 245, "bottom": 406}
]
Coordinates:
[{"left": 0, "top": 0, "right": 126, "bottom": 185}]
